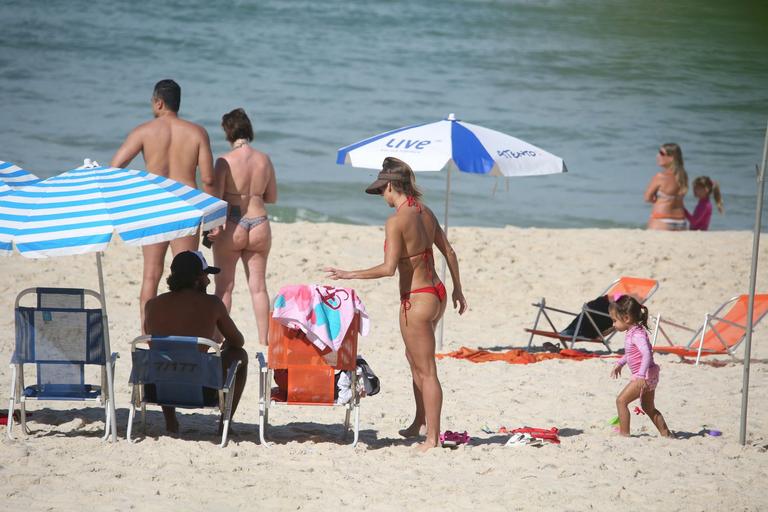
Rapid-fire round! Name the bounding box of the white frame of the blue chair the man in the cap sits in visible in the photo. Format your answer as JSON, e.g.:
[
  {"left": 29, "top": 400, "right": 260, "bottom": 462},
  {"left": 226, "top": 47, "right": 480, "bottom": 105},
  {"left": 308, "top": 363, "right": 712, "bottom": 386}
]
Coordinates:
[{"left": 125, "top": 334, "right": 240, "bottom": 448}]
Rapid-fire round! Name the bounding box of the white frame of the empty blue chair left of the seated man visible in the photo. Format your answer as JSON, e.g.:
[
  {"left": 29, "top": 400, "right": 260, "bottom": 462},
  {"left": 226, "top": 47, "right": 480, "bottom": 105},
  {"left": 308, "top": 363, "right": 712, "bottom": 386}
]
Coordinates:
[{"left": 6, "top": 287, "right": 120, "bottom": 441}]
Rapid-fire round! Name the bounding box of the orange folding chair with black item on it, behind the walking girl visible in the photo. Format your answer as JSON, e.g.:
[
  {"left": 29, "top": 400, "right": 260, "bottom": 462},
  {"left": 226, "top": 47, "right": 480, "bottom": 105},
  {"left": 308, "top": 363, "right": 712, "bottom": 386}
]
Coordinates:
[{"left": 525, "top": 276, "right": 659, "bottom": 352}]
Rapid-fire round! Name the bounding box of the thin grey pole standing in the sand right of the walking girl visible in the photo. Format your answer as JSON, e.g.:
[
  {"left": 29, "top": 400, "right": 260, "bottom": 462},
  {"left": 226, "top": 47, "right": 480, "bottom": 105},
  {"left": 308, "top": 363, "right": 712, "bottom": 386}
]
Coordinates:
[{"left": 739, "top": 122, "right": 768, "bottom": 446}]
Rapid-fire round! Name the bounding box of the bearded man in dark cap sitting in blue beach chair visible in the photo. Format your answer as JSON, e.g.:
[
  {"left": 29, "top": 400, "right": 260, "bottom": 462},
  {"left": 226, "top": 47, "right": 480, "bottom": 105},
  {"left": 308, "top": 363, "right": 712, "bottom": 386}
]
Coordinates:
[{"left": 138, "top": 251, "right": 248, "bottom": 433}]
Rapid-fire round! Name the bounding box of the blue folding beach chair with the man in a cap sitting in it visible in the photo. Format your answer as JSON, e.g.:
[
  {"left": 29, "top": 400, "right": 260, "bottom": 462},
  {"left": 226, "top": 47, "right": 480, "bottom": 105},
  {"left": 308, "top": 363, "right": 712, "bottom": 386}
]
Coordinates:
[{"left": 126, "top": 336, "right": 240, "bottom": 448}]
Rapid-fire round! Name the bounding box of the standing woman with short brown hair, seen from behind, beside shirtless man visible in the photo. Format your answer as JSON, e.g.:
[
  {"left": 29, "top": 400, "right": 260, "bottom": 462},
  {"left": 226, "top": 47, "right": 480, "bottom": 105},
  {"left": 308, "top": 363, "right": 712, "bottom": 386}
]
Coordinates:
[{"left": 208, "top": 108, "right": 277, "bottom": 345}]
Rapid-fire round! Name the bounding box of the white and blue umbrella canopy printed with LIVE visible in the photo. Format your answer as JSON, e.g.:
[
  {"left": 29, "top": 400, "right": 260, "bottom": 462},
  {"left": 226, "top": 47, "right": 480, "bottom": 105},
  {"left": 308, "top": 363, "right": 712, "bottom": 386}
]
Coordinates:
[{"left": 336, "top": 114, "right": 567, "bottom": 176}]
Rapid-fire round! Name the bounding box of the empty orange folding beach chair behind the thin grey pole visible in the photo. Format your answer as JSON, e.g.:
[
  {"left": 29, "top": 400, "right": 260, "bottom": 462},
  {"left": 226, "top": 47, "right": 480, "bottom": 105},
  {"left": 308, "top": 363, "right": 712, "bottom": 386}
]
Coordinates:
[{"left": 653, "top": 294, "right": 768, "bottom": 364}]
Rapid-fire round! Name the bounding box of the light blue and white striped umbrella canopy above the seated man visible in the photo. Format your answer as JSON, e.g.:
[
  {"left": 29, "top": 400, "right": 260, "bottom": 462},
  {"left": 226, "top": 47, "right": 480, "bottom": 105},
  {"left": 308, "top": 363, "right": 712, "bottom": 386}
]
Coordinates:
[{"left": 0, "top": 161, "right": 227, "bottom": 258}]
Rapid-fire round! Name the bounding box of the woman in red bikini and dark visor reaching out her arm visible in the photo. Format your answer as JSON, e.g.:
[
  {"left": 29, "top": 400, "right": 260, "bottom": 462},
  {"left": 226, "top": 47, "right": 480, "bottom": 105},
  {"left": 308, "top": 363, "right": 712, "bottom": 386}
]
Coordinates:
[{"left": 325, "top": 157, "right": 467, "bottom": 451}]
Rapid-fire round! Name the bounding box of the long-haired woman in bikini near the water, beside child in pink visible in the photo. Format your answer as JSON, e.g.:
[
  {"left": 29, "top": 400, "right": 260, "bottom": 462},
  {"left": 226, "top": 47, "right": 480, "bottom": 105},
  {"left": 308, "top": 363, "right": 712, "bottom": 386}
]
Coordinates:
[{"left": 645, "top": 143, "right": 688, "bottom": 231}]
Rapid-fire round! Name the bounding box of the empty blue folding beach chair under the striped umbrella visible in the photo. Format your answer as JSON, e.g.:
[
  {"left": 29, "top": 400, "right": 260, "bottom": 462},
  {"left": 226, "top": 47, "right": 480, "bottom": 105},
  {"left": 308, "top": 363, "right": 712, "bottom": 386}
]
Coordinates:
[{"left": 7, "top": 288, "right": 118, "bottom": 439}]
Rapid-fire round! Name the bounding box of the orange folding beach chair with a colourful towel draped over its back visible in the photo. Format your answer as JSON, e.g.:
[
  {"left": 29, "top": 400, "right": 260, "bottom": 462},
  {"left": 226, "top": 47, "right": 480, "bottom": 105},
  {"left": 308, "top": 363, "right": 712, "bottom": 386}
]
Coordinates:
[{"left": 257, "top": 314, "right": 360, "bottom": 446}]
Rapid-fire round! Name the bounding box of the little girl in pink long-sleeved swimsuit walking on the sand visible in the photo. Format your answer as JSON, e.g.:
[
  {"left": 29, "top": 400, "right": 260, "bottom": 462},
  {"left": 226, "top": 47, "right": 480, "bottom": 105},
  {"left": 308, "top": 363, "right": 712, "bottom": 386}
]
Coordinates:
[{"left": 608, "top": 295, "right": 672, "bottom": 437}]
